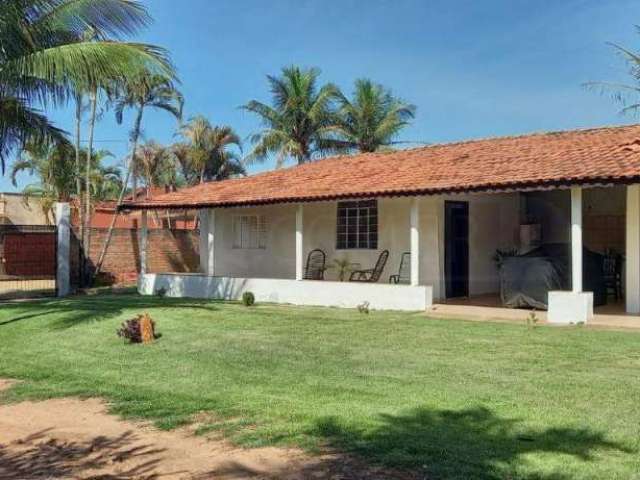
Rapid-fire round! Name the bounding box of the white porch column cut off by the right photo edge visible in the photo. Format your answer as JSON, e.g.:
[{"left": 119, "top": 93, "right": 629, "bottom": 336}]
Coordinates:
[{"left": 625, "top": 184, "right": 640, "bottom": 313}]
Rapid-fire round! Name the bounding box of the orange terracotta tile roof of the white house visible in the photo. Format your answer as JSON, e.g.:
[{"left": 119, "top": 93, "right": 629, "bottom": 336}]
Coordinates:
[{"left": 124, "top": 125, "right": 640, "bottom": 209}]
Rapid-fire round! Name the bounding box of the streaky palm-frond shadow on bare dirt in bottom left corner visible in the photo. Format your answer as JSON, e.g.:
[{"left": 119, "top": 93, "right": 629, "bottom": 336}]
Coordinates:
[{"left": 0, "top": 430, "right": 174, "bottom": 480}]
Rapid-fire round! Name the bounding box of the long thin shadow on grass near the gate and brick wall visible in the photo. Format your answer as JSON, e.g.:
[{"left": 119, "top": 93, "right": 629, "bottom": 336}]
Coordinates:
[{"left": 0, "top": 294, "right": 228, "bottom": 328}]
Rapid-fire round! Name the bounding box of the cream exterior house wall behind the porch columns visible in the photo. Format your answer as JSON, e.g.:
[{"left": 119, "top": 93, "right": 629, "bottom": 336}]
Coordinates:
[{"left": 195, "top": 194, "right": 520, "bottom": 299}]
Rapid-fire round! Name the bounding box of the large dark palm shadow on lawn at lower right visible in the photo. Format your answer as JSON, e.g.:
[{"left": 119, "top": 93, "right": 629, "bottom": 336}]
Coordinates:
[{"left": 310, "top": 407, "right": 634, "bottom": 480}]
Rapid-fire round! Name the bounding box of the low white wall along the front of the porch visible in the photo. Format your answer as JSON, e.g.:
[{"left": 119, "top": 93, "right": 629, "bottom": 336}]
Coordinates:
[{"left": 138, "top": 273, "right": 433, "bottom": 311}]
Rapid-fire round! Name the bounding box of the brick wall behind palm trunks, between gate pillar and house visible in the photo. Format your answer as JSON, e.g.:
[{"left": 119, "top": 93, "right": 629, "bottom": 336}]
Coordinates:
[{"left": 90, "top": 228, "right": 200, "bottom": 283}]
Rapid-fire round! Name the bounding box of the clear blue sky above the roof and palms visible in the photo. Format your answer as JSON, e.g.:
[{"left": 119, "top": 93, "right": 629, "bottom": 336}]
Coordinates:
[{"left": 5, "top": 0, "right": 640, "bottom": 191}]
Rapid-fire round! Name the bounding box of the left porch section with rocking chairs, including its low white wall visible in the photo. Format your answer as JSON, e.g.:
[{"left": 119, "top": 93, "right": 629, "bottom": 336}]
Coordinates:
[{"left": 138, "top": 197, "right": 434, "bottom": 311}]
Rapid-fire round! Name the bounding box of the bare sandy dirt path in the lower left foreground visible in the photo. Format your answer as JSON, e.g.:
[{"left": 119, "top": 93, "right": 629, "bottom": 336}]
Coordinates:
[{"left": 0, "top": 379, "right": 410, "bottom": 480}]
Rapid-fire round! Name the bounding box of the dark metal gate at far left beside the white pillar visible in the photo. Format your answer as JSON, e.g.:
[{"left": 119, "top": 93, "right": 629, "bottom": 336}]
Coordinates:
[{"left": 0, "top": 225, "right": 57, "bottom": 300}]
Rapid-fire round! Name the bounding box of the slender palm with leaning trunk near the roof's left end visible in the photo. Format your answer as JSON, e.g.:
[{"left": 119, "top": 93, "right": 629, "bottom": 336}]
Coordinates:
[{"left": 94, "top": 74, "right": 184, "bottom": 278}]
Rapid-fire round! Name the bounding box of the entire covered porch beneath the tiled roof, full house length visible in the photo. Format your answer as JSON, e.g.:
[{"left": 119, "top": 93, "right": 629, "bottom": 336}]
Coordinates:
[{"left": 139, "top": 184, "right": 640, "bottom": 324}]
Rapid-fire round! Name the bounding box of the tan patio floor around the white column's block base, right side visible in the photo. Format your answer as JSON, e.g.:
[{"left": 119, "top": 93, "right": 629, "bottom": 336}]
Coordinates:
[{"left": 427, "top": 295, "right": 640, "bottom": 329}]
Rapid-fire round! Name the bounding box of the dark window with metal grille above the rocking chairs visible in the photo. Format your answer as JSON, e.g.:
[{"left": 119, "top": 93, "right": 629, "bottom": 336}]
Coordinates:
[{"left": 336, "top": 200, "right": 378, "bottom": 250}]
